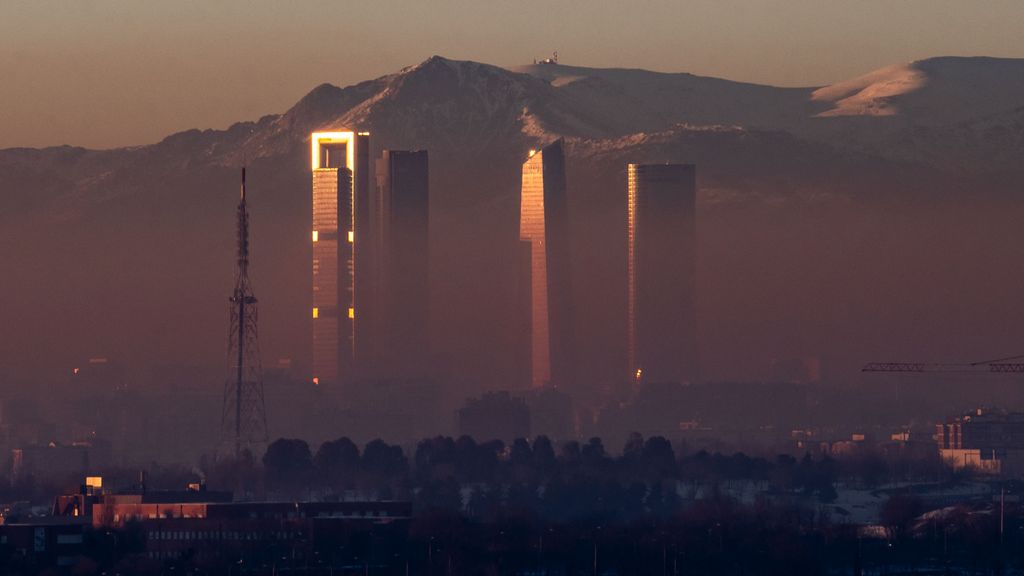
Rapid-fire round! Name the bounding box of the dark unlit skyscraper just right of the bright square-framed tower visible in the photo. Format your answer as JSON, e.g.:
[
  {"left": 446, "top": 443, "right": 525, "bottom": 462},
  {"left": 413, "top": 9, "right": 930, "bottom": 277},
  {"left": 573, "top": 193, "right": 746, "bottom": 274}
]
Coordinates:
[{"left": 376, "top": 150, "right": 430, "bottom": 377}]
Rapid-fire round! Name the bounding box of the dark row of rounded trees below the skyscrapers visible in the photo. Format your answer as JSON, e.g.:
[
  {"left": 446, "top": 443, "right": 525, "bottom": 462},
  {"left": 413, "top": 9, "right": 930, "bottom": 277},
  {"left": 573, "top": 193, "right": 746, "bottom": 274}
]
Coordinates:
[{"left": 253, "top": 435, "right": 841, "bottom": 507}]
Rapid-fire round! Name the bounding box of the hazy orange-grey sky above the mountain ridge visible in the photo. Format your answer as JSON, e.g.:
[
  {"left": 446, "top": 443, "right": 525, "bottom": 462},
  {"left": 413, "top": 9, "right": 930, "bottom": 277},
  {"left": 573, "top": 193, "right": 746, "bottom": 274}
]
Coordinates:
[{"left": 6, "top": 0, "right": 1024, "bottom": 148}]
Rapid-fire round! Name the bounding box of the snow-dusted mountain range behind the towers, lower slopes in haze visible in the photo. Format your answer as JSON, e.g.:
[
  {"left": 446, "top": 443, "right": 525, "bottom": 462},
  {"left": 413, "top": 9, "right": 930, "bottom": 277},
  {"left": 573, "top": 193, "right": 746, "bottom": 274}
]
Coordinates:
[{"left": 0, "top": 56, "right": 1024, "bottom": 401}]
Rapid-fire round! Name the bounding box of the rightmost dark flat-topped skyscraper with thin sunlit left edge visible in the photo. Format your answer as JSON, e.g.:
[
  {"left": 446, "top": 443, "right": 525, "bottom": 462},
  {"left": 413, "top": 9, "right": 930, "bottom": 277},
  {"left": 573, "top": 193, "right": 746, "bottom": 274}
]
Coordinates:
[{"left": 627, "top": 164, "right": 697, "bottom": 382}]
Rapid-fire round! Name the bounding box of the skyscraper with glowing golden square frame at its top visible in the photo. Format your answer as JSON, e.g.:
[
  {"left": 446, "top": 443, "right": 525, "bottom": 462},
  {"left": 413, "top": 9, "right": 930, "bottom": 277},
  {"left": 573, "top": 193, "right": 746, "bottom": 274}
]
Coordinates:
[{"left": 310, "top": 132, "right": 370, "bottom": 385}]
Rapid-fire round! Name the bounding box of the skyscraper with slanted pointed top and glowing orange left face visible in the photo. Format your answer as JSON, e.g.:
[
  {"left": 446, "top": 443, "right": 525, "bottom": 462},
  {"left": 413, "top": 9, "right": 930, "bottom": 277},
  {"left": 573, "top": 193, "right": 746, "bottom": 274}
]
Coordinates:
[{"left": 519, "top": 139, "right": 573, "bottom": 386}]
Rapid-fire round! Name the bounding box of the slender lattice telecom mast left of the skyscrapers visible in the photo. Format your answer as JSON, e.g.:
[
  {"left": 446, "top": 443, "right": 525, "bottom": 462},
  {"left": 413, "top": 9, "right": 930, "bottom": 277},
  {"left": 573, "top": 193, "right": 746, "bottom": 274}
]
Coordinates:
[{"left": 220, "top": 168, "right": 268, "bottom": 457}]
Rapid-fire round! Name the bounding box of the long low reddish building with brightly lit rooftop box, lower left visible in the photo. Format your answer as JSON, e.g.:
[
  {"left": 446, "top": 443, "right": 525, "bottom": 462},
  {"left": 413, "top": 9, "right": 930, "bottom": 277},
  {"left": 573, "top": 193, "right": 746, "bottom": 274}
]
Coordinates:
[{"left": 45, "top": 479, "right": 413, "bottom": 564}]
